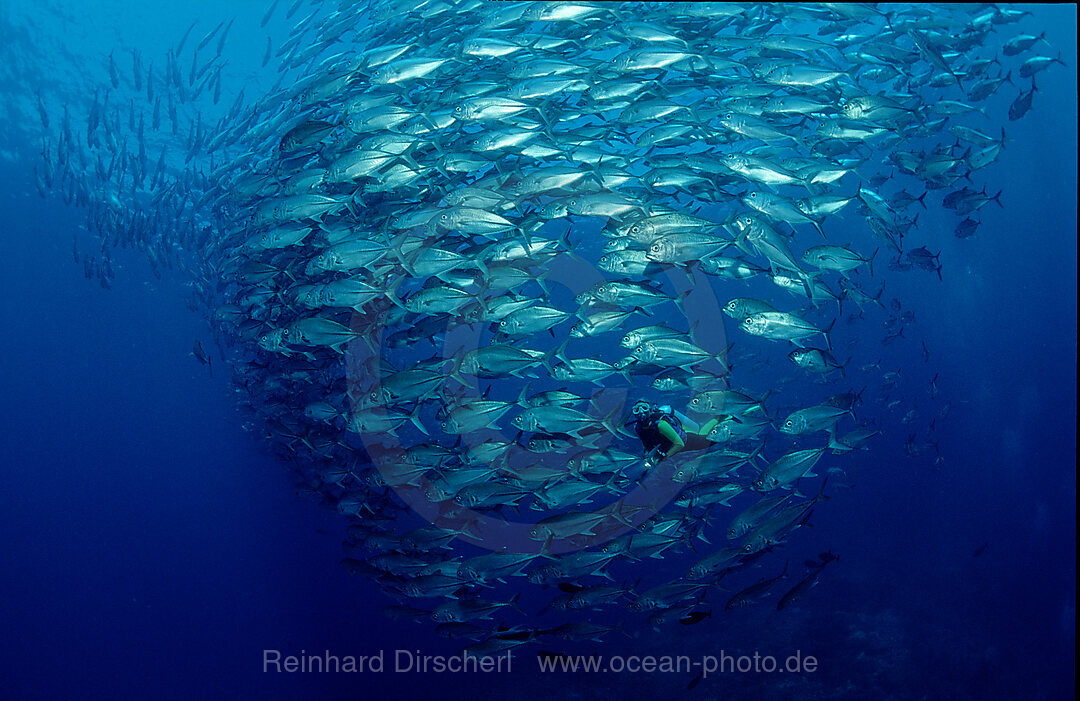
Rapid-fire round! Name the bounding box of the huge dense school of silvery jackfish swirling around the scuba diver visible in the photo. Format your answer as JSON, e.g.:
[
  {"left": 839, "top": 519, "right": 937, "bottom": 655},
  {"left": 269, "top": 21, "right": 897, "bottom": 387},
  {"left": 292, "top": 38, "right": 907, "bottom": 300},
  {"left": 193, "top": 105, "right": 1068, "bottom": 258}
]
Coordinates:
[{"left": 27, "top": 0, "right": 1061, "bottom": 655}]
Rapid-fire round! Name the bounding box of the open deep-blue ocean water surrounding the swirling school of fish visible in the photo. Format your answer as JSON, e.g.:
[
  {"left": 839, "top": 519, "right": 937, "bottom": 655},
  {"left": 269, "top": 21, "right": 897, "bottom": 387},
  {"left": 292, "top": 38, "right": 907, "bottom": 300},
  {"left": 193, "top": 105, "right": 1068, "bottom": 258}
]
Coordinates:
[{"left": 0, "top": 0, "right": 1077, "bottom": 699}]
